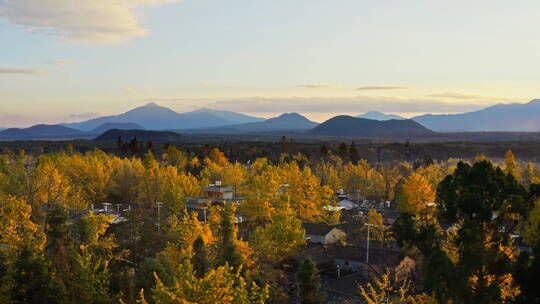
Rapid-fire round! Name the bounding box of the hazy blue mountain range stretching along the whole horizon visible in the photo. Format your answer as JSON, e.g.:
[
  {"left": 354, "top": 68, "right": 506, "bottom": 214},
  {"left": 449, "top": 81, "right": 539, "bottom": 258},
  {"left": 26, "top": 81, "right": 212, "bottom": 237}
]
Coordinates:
[{"left": 0, "top": 99, "right": 540, "bottom": 140}]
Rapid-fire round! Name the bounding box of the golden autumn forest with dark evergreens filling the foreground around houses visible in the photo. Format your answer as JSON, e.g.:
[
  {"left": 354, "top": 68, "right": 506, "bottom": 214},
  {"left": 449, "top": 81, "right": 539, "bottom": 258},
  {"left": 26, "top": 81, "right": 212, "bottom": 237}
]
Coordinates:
[{"left": 0, "top": 139, "right": 540, "bottom": 304}]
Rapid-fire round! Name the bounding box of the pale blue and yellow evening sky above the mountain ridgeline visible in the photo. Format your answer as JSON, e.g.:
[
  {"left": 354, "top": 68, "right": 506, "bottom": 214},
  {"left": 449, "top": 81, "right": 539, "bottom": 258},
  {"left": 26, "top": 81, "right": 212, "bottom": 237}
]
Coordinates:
[{"left": 0, "top": 0, "right": 540, "bottom": 127}]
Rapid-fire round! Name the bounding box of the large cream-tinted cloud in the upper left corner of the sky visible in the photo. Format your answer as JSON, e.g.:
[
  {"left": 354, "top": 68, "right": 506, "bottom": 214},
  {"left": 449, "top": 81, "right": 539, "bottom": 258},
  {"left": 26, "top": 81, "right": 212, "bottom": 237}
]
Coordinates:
[{"left": 0, "top": 0, "right": 182, "bottom": 43}]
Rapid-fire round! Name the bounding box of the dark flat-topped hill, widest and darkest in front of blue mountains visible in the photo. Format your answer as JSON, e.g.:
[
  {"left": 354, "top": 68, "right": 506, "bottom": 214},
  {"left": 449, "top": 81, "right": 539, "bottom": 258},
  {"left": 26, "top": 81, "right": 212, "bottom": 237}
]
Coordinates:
[{"left": 309, "top": 115, "right": 437, "bottom": 138}]
